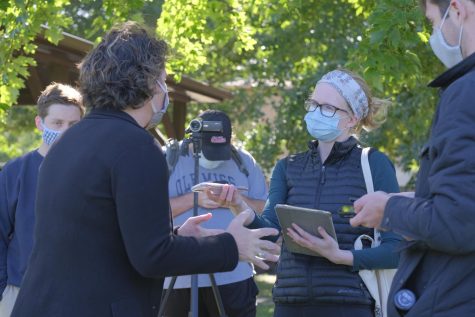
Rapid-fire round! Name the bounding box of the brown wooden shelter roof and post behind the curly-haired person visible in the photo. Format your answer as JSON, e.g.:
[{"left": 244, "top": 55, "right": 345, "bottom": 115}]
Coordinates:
[{"left": 18, "top": 32, "right": 232, "bottom": 139}]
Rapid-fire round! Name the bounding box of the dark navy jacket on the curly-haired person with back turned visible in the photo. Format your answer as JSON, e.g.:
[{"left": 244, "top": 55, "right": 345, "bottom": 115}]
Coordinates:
[{"left": 12, "top": 110, "right": 238, "bottom": 317}]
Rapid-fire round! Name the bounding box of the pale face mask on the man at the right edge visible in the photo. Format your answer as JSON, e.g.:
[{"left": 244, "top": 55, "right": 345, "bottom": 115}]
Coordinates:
[{"left": 429, "top": 6, "right": 463, "bottom": 68}]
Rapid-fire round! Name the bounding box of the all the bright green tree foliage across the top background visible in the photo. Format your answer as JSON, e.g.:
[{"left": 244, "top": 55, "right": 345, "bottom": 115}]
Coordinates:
[{"left": 0, "top": 0, "right": 443, "bottom": 179}]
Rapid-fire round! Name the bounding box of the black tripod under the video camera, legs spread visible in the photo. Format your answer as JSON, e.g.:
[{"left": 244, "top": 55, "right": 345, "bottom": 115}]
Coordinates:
[{"left": 158, "top": 132, "right": 226, "bottom": 317}]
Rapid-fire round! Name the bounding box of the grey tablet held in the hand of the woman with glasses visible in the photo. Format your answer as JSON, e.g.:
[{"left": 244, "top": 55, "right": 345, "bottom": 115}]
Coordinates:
[{"left": 275, "top": 204, "right": 338, "bottom": 256}]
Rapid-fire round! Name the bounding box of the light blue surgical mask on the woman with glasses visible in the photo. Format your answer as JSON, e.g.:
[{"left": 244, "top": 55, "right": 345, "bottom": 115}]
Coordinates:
[{"left": 304, "top": 109, "right": 342, "bottom": 142}]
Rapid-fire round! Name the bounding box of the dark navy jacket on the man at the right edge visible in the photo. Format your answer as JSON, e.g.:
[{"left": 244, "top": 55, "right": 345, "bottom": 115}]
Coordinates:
[{"left": 383, "top": 54, "right": 475, "bottom": 317}]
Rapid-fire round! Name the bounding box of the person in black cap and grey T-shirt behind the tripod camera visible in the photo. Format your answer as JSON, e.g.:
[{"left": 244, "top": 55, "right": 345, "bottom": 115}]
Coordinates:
[{"left": 165, "top": 110, "right": 267, "bottom": 317}]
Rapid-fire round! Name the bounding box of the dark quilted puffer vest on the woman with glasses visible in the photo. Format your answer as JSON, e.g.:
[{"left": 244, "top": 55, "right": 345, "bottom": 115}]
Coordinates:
[{"left": 273, "top": 138, "right": 372, "bottom": 305}]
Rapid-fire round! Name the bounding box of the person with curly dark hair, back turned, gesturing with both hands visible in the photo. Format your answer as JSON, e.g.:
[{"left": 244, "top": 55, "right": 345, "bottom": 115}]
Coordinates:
[{"left": 9, "top": 22, "right": 278, "bottom": 317}]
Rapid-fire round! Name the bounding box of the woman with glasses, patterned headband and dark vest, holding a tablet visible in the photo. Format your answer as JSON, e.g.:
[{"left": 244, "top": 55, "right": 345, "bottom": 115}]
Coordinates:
[{"left": 208, "top": 70, "right": 400, "bottom": 317}]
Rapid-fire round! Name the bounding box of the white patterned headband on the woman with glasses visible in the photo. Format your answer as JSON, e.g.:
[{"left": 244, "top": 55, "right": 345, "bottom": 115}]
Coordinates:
[{"left": 317, "top": 70, "right": 369, "bottom": 120}]
